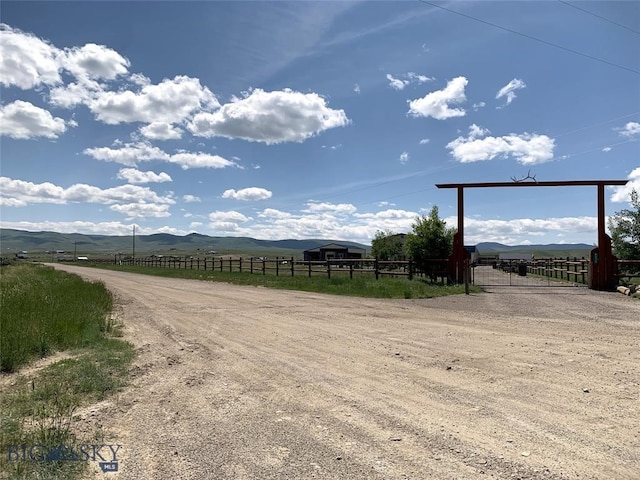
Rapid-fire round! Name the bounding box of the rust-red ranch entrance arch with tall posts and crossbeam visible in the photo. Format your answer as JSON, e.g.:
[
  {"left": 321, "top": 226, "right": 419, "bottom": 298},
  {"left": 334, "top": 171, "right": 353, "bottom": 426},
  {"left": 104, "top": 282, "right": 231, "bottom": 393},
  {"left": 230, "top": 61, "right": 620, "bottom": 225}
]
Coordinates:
[{"left": 436, "top": 180, "right": 627, "bottom": 290}]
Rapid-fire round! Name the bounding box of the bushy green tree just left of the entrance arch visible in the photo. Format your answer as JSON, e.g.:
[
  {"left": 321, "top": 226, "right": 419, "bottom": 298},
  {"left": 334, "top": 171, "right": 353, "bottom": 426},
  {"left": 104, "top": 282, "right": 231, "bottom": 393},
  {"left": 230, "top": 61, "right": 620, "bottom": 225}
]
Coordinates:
[{"left": 405, "top": 205, "right": 456, "bottom": 278}]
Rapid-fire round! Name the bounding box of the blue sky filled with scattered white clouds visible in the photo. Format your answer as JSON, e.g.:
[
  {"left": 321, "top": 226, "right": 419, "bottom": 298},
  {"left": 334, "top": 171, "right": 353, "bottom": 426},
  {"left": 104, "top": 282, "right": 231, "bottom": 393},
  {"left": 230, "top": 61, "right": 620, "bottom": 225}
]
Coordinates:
[{"left": 0, "top": 1, "right": 640, "bottom": 248}]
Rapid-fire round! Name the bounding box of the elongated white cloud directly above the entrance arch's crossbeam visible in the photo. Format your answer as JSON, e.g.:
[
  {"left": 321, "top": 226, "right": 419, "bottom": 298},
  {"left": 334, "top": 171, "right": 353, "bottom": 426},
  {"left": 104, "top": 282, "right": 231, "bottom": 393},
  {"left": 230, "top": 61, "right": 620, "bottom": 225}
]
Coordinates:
[{"left": 447, "top": 124, "right": 555, "bottom": 165}]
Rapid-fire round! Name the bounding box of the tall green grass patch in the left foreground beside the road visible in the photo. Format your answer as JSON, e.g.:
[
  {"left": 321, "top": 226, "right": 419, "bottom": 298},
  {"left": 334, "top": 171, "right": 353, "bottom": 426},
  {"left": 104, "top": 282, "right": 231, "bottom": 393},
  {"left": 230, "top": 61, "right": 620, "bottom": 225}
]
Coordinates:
[{"left": 0, "top": 264, "right": 134, "bottom": 479}]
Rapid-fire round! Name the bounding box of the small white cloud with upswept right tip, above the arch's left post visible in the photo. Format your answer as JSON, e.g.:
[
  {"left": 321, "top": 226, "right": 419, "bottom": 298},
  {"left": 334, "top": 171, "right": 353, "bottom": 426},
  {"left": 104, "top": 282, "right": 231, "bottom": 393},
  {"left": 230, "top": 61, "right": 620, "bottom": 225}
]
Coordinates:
[{"left": 409, "top": 77, "right": 469, "bottom": 120}]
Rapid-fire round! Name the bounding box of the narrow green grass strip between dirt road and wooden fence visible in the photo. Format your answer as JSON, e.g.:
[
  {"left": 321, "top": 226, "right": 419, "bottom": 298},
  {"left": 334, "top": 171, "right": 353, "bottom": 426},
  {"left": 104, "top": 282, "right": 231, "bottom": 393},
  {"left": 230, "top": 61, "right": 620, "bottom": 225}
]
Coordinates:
[{"left": 92, "top": 264, "right": 481, "bottom": 298}]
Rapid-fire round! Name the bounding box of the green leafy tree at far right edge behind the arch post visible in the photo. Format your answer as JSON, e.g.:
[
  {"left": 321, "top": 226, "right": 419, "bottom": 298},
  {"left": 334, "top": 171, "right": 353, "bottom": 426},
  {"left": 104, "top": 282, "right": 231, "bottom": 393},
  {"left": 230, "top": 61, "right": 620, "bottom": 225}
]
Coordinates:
[{"left": 609, "top": 189, "right": 640, "bottom": 260}]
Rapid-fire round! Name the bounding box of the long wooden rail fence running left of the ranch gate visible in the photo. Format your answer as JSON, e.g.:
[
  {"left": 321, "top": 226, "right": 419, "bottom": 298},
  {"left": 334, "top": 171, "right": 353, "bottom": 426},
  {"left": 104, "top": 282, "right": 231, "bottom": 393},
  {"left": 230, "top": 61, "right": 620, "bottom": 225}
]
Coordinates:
[{"left": 114, "top": 256, "right": 448, "bottom": 283}]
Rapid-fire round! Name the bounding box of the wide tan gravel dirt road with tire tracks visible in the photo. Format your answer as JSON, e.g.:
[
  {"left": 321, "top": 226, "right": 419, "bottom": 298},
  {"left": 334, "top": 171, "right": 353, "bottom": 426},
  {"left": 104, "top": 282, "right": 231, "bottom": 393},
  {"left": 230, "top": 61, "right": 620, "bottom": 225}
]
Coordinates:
[{"left": 48, "top": 265, "right": 640, "bottom": 480}]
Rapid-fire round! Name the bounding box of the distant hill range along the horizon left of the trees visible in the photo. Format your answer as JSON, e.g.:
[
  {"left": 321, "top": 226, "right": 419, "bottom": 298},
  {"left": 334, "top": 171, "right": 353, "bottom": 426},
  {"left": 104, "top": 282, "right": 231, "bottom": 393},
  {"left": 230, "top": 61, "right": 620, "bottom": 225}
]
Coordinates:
[{"left": 0, "top": 228, "right": 371, "bottom": 256}]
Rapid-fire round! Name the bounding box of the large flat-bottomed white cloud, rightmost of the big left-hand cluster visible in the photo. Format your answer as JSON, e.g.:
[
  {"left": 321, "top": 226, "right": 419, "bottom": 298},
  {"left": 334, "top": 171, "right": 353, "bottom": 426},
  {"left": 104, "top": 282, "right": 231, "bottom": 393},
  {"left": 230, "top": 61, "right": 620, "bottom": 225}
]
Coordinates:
[{"left": 189, "top": 88, "right": 350, "bottom": 145}]
